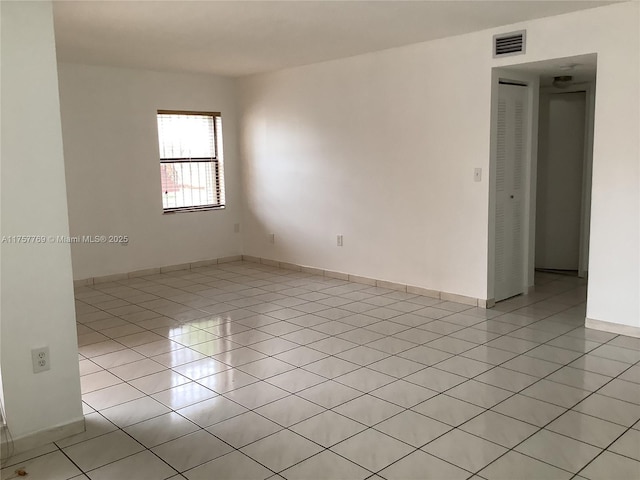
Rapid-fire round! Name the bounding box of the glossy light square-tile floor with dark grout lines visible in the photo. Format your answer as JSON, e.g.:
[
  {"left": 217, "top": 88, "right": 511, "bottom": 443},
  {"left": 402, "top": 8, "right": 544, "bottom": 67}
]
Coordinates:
[{"left": 1, "top": 262, "right": 640, "bottom": 480}]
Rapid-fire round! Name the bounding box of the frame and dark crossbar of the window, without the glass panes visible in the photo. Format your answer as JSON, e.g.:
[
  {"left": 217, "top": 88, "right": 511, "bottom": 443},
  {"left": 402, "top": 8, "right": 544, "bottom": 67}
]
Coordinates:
[{"left": 156, "top": 109, "right": 226, "bottom": 215}]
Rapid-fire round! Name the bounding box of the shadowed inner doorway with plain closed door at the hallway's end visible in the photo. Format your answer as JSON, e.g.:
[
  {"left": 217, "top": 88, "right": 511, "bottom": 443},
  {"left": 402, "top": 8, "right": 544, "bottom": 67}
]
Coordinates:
[{"left": 535, "top": 76, "right": 595, "bottom": 278}]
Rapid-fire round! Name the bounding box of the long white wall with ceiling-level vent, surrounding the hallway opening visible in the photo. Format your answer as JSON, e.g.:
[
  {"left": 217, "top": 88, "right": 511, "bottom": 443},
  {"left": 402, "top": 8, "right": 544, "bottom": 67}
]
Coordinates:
[{"left": 241, "top": 2, "right": 640, "bottom": 325}]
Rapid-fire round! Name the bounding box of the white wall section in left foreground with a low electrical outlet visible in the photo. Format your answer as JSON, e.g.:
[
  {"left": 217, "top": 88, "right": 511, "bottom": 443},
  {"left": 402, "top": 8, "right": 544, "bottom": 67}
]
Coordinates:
[{"left": 0, "top": 2, "right": 82, "bottom": 440}]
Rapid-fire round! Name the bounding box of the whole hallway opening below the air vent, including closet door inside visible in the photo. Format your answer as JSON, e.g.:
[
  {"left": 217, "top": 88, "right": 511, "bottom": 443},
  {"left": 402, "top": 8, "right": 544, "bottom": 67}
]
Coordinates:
[{"left": 487, "top": 54, "right": 596, "bottom": 319}]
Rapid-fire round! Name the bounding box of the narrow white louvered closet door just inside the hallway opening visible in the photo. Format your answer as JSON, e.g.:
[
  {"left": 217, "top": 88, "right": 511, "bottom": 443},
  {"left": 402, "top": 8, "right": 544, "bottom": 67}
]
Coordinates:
[{"left": 495, "top": 84, "right": 527, "bottom": 301}]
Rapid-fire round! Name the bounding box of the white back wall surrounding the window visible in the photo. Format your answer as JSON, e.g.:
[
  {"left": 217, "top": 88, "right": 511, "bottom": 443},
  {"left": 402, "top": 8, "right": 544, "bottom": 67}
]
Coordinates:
[{"left": 59, "top": 64, "right": 242, "bottom": 279}]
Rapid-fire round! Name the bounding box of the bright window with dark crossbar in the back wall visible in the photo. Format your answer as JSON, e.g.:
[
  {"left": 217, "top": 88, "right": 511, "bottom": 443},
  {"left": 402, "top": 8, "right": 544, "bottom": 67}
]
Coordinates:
[{"left": 158, "top": 110, "right": 224, "bottom": 213}]
